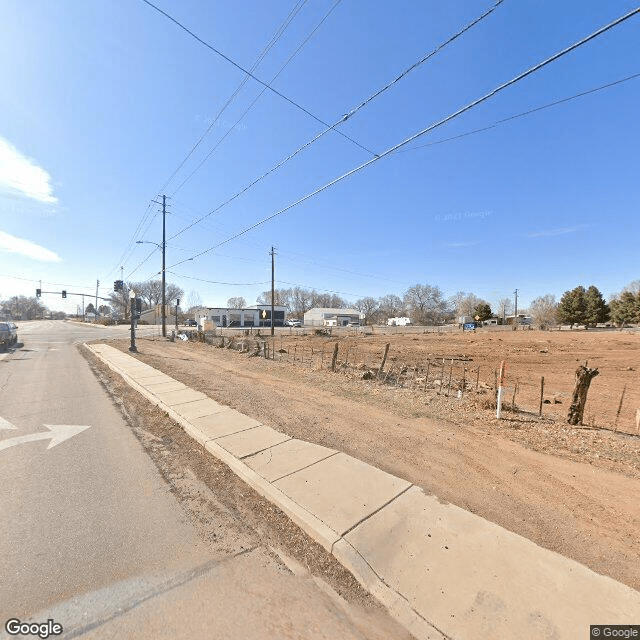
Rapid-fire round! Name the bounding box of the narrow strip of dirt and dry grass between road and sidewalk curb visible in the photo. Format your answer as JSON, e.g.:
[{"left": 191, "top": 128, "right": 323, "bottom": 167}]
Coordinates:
[{"left": 81, "top": 349, "right": 411, "bottom": 640}]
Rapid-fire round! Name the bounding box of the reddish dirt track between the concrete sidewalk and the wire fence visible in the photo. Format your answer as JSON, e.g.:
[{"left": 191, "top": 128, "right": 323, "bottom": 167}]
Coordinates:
[{"left": 102, "top": 338, "right": 640, "bottom": 590}]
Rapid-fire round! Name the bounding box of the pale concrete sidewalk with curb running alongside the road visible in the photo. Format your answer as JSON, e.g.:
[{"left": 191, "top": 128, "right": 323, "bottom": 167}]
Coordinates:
[{"left": 87, "top": 345, "right": 640, "bottom": 640}]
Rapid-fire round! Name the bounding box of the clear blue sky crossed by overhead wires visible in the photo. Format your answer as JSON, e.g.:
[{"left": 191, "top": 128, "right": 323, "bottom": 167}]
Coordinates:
[{"left": 0, "top": 0, "right": 640, "bottom": 312}]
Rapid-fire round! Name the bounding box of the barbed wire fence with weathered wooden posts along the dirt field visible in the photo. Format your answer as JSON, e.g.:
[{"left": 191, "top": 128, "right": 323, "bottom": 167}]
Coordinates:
[{"left": 182, "top": 327, "right": 640, "bottom": 435}]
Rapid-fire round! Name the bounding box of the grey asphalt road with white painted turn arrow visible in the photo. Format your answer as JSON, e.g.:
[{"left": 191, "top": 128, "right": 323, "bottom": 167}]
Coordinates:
[{"left": 0, "top": 321, "right": 404, "bottom": 639}]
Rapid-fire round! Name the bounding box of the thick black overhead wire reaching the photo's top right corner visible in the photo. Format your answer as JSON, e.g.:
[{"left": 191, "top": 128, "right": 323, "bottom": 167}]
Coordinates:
[{"left": 168, "top": 6, "right": 640, "bottom": 267}]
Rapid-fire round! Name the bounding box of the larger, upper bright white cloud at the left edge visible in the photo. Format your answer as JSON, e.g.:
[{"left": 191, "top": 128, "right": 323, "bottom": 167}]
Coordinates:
[{"left": 0, "top": 137, "right": 58, "bottom": 204}]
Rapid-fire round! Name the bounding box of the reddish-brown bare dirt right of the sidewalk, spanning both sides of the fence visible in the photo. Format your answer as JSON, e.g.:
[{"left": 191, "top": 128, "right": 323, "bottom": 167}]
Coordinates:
[{"left": 96, "top": 331, "right": 640, "bottom": 589}]
